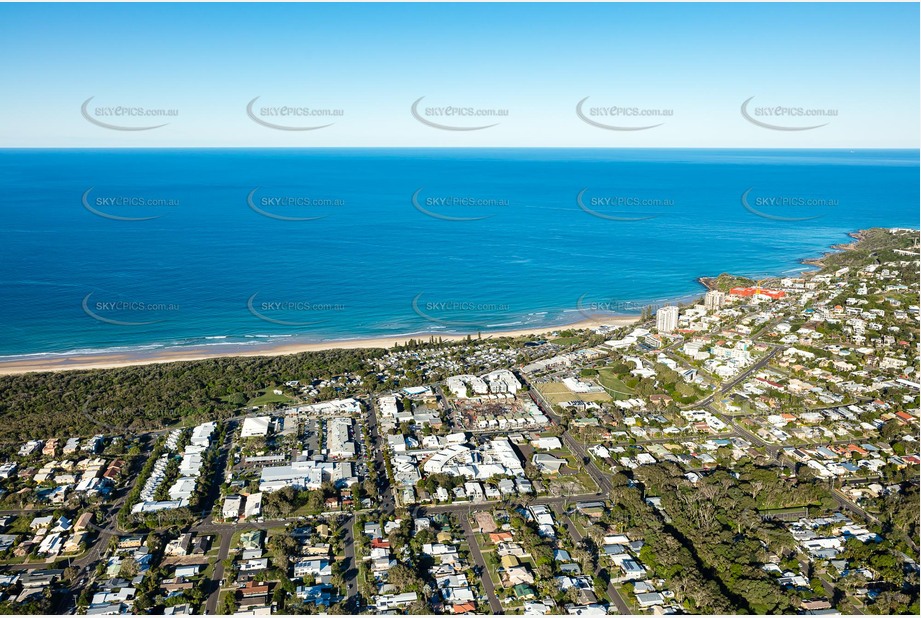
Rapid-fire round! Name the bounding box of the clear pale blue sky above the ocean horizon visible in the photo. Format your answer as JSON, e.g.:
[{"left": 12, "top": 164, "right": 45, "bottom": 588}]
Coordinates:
[{"left": 0, "top": 3, "right": 919, "bottom": 148}]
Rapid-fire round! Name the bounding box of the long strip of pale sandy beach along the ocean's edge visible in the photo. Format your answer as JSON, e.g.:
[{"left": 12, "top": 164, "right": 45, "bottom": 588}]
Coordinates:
[{"left": 0, "top": 316, "right": 639, "bottom": 375}]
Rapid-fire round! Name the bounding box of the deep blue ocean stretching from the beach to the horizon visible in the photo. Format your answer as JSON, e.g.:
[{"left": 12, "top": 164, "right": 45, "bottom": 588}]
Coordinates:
[{"left": 0, "top": 149, "right": 919, "bottom": 357}]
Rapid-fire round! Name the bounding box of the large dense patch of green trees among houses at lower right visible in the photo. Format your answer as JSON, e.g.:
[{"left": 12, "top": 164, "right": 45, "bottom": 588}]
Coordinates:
[{"left": 605, "top": 464, "right": 834, "bottom": 614}]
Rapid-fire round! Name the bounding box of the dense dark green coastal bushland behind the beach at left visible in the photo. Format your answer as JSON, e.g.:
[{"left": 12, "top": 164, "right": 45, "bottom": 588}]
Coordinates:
[{"left": 0, "top": 349, "right": 384, "bottom": 443}]
